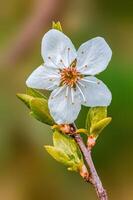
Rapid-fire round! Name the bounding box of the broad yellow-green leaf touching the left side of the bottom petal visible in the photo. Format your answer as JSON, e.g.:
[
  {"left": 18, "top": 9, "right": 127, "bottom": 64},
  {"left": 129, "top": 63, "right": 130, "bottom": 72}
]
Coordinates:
[{"left": 30, "top": 98, "right": 55, "bottom": 126}]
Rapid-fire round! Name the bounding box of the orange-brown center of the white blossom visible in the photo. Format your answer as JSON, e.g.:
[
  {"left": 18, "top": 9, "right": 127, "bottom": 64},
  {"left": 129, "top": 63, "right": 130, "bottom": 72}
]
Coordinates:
[{"left": 60, "top": 66, "right": 82, "bottom": 87}]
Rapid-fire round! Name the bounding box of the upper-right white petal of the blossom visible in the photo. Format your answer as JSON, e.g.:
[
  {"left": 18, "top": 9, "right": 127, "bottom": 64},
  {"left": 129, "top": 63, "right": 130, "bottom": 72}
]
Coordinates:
[{"left": 77, "top": 37, "right": 112, "bottom": 75}]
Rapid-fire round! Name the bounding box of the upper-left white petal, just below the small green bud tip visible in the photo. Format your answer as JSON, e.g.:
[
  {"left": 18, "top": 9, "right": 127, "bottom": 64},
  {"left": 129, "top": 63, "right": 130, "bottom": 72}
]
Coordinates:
[{"left": 41, "top": 29, "right": 77, "bottom": 68}]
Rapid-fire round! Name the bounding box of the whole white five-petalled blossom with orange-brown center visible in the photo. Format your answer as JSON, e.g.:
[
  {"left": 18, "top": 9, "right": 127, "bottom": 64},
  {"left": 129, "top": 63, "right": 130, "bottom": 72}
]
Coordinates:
[{"left": 26, "top": 29, "right": 112, "bottom": 124}]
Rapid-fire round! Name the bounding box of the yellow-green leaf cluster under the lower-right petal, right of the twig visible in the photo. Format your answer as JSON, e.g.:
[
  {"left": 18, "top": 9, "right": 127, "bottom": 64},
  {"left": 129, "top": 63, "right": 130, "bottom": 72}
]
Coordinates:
[{"left": 86, "top": 107, "right": 111, "bottom": 138}]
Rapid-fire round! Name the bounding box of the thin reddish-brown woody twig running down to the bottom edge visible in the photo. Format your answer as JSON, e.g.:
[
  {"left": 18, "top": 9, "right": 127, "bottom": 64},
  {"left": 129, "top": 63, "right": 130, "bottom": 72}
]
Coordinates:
[{"left": 73, "top": 124, "right": 108, "bottom": 200}]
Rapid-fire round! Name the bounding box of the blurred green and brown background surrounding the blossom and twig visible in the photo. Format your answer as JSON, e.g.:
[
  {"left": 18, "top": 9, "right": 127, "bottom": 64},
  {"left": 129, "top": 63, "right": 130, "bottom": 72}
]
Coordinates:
[{"left": 0, "top": 0, "right": 133, "bottom": 200}]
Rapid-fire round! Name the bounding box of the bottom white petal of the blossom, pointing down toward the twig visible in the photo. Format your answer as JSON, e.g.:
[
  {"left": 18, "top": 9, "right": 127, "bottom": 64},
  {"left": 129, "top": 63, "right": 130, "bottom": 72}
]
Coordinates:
[{"left": 48, "top": 86, "right": 81, "bottom": 124}]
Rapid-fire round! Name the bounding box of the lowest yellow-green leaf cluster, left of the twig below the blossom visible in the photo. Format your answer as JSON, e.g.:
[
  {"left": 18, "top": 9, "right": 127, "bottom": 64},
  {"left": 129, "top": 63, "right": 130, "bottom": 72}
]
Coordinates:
[{"left": 45, "top": 130, "right": 84, "bottom": 171}]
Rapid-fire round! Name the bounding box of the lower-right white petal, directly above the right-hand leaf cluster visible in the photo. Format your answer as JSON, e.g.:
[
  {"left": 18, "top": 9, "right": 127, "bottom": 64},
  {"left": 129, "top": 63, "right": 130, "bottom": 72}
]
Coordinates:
[{"left": 79, "top": 76, "right": 112, "bottom": 107}]
